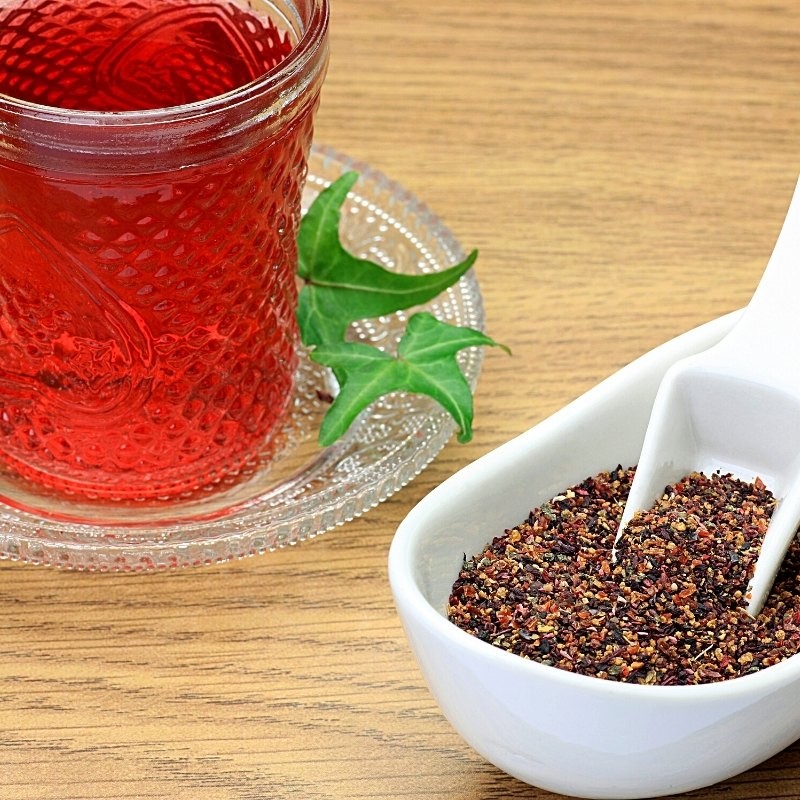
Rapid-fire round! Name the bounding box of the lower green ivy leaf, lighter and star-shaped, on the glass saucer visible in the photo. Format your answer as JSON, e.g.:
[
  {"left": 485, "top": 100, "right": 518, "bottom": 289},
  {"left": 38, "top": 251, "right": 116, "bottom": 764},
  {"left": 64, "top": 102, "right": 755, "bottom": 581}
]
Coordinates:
[{"left": 311, "top": 312, "right": 507, "bottom": 446}]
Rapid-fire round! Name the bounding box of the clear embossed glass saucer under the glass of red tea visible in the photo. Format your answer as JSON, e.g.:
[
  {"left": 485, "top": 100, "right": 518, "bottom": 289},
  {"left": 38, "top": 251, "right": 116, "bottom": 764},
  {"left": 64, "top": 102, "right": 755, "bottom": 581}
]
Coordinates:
[{"left": 0, "top": 146, "right": 484, "bottom": 572}]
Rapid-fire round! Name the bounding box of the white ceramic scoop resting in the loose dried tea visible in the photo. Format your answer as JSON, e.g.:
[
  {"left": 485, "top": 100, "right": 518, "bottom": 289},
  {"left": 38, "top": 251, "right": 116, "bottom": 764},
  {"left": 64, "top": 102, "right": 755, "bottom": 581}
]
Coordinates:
[{"left": 617, "top": 182, "right": 800, "bottom": 617}]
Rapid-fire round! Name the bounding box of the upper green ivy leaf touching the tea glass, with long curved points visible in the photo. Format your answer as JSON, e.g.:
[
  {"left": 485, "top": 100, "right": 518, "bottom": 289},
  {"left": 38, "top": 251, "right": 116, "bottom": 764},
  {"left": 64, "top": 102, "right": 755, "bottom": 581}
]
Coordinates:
[{"left": 297, "top": 172, "right": 478, "bottom": 347}]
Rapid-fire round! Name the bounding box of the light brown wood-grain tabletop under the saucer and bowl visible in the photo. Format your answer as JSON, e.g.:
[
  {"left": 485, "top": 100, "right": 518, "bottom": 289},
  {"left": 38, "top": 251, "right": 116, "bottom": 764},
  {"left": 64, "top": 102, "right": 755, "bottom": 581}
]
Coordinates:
[{"left": 0, "top": 0, "right": 800, "bottom": 800}]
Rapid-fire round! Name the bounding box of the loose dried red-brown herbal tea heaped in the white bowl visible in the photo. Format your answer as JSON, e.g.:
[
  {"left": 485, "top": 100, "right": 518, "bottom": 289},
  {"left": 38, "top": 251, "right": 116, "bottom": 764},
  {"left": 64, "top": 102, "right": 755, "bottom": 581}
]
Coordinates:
[{"left": 448, "top": 467, "right": 800, "bottom": 685}]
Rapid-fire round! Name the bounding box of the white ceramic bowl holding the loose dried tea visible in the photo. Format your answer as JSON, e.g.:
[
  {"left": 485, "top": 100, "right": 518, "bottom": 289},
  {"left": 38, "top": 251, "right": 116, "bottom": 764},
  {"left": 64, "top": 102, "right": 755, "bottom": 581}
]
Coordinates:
[{"left": 389, "top": 315, "right": 800, "bottom": 800}]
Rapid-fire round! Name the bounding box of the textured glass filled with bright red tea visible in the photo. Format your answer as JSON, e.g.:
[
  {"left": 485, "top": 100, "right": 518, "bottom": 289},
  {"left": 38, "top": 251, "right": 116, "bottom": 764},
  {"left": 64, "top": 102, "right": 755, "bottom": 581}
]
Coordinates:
[{"left": 0, "top": 0, "right": 328, "bottom": 500}]
